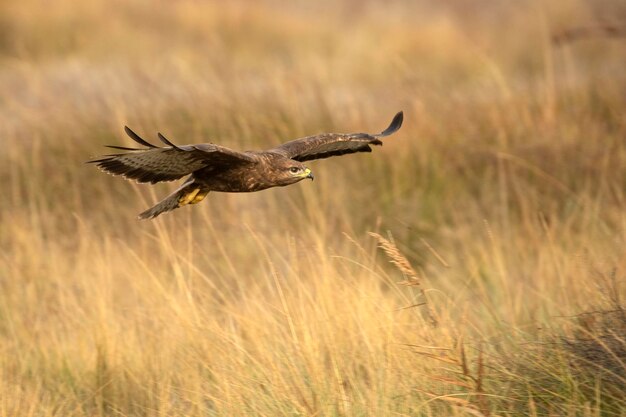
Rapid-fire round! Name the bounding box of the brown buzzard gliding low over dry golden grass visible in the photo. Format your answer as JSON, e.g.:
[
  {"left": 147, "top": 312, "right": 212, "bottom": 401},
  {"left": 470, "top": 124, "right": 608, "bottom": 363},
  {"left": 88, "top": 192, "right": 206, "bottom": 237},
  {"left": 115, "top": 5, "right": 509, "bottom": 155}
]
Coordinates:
[{"left": 89, "top": 112, "right": 403, "bottom": 219}]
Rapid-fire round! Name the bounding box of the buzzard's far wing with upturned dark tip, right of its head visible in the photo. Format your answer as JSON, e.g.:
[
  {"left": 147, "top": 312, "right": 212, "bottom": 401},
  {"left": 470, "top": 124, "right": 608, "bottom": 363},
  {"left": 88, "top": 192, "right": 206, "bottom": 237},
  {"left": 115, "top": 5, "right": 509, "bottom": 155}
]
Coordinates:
[{"left": 269, "top": 112, "right": 404, "bottom": 162}]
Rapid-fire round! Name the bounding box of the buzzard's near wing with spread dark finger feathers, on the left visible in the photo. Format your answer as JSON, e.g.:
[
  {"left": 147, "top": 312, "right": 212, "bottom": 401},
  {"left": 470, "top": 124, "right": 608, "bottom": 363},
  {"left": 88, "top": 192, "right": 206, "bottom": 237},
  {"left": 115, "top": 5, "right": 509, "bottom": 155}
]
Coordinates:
[{"left": 88, "top": 127, "right": 256, "bottom": 184}]
